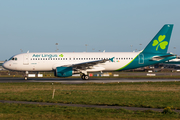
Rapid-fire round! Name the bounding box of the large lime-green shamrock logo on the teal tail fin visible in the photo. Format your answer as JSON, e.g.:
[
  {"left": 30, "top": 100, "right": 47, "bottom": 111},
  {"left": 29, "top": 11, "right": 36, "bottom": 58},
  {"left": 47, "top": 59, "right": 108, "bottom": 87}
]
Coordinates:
[{"left": 152, "top": 35, "right": 168, "bottom": 51}]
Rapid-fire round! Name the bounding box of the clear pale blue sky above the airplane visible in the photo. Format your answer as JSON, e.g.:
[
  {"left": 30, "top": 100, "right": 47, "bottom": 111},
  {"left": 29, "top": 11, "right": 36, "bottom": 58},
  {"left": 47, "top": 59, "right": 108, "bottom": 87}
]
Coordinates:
[{"left": 0, "top": 0, "right": 180, "bottom": 61}]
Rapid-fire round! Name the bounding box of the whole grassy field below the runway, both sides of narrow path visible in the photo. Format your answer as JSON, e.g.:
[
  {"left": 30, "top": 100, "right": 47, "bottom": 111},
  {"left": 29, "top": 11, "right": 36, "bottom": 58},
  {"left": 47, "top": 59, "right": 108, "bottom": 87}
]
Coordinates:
[{"left": 0, "top": 82, "right": 180, "bottom": 120}]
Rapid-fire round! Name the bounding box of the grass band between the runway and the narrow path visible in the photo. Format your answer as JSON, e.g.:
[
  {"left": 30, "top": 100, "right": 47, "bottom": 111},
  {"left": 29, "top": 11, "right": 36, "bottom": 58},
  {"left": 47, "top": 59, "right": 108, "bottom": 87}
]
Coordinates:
[{"left": 0, "top": 82, "right": 180, "bottom": 109}]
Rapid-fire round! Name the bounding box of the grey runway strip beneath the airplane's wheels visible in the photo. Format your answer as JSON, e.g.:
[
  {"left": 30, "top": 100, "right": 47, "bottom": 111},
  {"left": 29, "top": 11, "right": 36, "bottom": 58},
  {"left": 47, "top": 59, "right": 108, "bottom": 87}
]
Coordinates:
[{"left": 0, "top": 78, "right": 180, "bottom": 84}]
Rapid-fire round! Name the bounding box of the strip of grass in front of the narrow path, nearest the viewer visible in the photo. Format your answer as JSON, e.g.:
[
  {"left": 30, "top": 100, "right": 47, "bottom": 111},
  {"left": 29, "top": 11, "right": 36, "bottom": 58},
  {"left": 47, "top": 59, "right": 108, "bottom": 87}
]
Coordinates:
[{"left": 0, "top": 103, "right": 180, "bottom": 120}]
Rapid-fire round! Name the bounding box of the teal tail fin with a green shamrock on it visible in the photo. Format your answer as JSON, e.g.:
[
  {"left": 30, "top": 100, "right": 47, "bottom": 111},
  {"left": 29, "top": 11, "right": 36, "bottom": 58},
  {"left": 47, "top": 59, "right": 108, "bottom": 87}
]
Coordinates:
[{"left": 143, "top": 24, "right": 173, "bottom": 53}]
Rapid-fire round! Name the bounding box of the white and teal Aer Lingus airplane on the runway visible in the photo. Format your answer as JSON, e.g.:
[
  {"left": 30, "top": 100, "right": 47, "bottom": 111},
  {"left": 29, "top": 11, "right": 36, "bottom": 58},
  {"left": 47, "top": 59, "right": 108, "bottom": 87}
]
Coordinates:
[{"left": 3, "top": 24, "right": 176, "bottom": 80}]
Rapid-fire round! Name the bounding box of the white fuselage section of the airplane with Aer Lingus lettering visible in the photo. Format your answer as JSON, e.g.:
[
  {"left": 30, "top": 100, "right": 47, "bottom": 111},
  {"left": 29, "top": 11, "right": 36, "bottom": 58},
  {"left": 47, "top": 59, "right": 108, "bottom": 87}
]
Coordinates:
[{"left": 3, "top": 52, "right": 139, "bottom": 72}]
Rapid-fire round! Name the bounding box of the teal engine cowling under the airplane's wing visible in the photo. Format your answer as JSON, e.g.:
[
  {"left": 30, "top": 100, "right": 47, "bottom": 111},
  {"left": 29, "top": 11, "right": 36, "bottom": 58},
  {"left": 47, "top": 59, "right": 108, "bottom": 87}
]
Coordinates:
[{"left": 54, "top": 67, "right": 73, "bottom": 77}]
